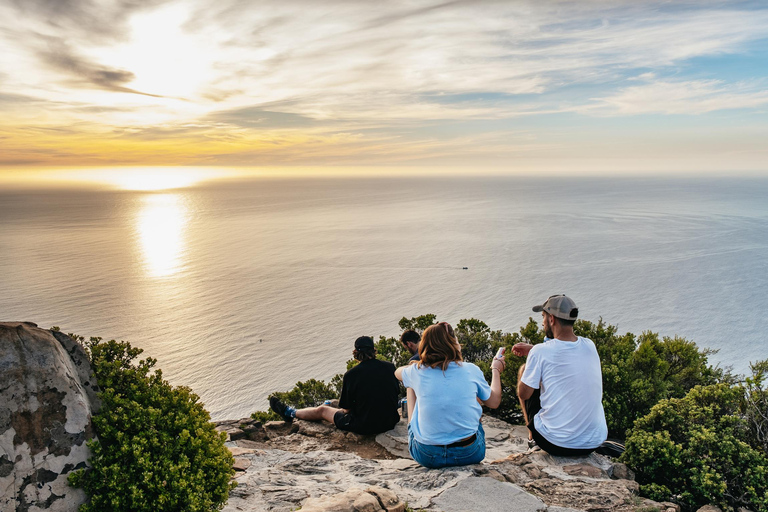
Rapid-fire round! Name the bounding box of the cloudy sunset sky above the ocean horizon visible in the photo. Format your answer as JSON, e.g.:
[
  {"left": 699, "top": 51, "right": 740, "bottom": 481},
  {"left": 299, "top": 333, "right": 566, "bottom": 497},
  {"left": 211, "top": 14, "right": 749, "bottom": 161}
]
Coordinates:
[{"left": 0, "top": 0, "right": 768, "bottom": 175}]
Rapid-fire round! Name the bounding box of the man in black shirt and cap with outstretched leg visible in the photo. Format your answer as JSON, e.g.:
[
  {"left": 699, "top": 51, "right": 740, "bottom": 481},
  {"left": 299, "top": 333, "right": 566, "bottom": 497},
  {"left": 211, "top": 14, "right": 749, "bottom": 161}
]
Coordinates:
[{"left": 269, "top": 336, "right": 400, "bottom": 434}]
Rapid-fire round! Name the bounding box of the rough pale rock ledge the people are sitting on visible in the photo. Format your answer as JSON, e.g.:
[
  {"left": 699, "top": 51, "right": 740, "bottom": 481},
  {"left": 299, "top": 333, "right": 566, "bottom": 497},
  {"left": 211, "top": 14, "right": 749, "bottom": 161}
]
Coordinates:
[{"left": 219, "top": 417, "right": 679, "bottom": 512}]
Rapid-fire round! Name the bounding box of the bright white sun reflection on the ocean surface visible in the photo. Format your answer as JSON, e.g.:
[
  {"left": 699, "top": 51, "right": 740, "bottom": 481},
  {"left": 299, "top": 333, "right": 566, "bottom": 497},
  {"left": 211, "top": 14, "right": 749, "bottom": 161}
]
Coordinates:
[{"left": 136, "top": 194, "right": 189, "bottom": 278}]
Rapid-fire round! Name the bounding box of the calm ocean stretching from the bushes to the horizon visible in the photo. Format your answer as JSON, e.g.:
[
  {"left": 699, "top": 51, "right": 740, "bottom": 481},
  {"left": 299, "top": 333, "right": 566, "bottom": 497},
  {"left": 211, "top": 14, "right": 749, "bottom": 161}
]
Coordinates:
[{"left": 0, "top": 177, "right": 768, "bottom": 419}]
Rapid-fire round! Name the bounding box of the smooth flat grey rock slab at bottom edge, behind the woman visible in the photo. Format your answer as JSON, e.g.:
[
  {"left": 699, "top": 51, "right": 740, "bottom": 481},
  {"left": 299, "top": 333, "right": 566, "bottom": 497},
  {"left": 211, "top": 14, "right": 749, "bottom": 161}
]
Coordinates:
[{"left": 433, "top": 477, "right": 547, "bottom": 512}]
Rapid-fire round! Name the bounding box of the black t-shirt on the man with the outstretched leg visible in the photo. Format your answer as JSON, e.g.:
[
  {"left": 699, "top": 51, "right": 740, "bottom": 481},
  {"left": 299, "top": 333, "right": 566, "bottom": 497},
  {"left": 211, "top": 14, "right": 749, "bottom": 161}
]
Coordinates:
[{"left": 339, "top": 359, "right": 400, "bottom": 434}]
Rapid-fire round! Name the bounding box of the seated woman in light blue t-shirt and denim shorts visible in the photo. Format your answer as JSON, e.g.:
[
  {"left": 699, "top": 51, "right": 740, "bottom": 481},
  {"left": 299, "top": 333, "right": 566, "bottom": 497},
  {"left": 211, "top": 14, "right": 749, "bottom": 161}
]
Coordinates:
[{"left": 395, "top": 322, "right": 504, "bottom": 468}]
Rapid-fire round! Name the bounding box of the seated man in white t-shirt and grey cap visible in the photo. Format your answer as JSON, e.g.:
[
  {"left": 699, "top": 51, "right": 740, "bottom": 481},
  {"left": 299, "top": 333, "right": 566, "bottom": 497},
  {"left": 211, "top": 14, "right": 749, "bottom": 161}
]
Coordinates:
[{"left": 512, "top": 295, "right": 608, "bottom": 456}]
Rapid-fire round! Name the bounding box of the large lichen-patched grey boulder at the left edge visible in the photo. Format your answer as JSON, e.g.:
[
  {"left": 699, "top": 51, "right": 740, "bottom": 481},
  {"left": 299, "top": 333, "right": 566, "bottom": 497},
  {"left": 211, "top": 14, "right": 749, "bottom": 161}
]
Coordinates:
[{"left": 0, "top": 322, "right": 98, "bottom": 512}]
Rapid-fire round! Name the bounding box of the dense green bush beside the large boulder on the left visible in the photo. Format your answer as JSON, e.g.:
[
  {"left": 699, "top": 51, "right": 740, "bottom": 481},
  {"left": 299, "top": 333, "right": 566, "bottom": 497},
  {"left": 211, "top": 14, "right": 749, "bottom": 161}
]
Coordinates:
[{"left": 69, "top": 335, "right": 234, "bottom": 512}]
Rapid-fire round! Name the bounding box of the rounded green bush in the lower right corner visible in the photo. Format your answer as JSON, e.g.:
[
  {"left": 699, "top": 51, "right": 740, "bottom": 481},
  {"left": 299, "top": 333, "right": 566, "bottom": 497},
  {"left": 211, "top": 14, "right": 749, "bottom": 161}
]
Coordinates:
[{"left": 622, "top": 383, "right": 768, "bottom": 511}]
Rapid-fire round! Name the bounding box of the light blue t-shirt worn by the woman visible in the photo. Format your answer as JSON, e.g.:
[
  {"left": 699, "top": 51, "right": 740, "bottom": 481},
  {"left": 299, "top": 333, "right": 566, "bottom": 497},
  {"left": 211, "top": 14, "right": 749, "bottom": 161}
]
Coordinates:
[{"left": 403, "top": 362, "right": 491, "bottom": 445}]
